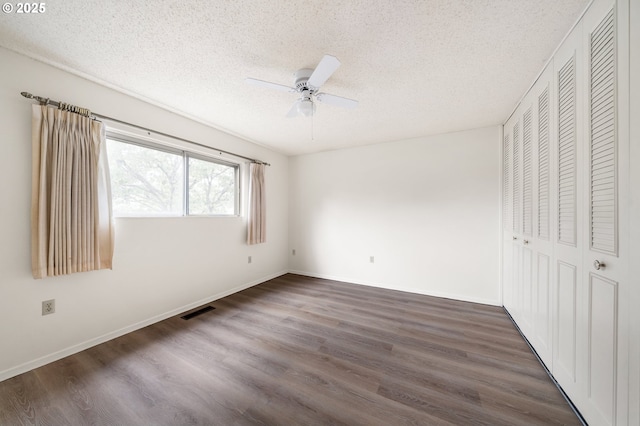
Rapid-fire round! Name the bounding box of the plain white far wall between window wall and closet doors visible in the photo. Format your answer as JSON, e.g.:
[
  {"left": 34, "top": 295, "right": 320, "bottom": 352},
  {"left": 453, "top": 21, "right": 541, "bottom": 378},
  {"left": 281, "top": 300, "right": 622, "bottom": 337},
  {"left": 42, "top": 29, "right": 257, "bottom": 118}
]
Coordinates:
[{"left": 289, "top": 127, "right": 501, "bottom": 305}]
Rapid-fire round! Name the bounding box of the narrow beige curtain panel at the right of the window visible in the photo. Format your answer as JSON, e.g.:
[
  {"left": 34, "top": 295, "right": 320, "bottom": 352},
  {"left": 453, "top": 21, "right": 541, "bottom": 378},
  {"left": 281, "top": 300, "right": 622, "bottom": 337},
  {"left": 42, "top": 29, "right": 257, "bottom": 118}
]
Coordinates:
[{"left": 247, "top": 163, "right": 267, "bottom": 245}]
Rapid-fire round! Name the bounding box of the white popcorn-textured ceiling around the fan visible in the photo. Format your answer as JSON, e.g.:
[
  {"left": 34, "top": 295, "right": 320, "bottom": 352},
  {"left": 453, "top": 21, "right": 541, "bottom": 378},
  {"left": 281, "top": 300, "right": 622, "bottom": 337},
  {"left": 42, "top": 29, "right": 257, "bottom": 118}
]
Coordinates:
[{"left": 0, "top": 0, "right": 588, "bottom": 154}]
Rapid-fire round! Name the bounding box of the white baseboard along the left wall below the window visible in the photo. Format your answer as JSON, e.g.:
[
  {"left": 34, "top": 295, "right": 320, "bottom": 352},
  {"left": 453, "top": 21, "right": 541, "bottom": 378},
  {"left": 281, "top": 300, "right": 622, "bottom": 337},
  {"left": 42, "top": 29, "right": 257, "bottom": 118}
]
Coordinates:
[{"left": 0, "top": 270, "right": 287, "bottom": 382}]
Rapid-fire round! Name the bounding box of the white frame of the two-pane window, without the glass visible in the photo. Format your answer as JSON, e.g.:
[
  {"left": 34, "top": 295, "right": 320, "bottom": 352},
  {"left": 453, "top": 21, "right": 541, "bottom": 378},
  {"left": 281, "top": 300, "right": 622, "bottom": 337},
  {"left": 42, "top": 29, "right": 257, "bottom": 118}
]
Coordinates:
[{"left": 106, "top": 128, "right": 242, "bottom": 218}]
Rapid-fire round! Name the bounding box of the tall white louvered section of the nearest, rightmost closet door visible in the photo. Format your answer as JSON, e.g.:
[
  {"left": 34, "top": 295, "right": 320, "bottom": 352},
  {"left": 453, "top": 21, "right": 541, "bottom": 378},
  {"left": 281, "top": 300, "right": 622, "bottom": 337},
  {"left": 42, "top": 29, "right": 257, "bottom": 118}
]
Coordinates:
[{"left": 589, "top": 11, "right": 618, "bottom": 255}]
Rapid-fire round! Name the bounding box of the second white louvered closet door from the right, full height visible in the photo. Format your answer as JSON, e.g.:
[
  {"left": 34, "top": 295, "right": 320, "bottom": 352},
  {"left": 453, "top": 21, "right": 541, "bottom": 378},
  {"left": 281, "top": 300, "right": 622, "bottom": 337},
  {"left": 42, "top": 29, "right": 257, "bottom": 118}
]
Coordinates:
[{"left": 550, "top": 25, "right": 587, "bottom": 401}]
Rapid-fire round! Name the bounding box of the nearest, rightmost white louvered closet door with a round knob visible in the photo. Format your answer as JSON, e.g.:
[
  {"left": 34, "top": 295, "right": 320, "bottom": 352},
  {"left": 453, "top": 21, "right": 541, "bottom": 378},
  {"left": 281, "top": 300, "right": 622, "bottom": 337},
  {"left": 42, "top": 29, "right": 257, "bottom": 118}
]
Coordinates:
[{"left": 583, "top": 1, "right": 628, "bottom": 425}]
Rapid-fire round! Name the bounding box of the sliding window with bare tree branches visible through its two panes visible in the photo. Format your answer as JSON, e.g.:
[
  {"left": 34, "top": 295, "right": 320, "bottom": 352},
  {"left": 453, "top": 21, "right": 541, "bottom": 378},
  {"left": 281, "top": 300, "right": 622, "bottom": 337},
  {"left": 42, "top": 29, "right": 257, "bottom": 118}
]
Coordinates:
[{"left": 107, "top": 135, "right": 239, "bottom": 216}]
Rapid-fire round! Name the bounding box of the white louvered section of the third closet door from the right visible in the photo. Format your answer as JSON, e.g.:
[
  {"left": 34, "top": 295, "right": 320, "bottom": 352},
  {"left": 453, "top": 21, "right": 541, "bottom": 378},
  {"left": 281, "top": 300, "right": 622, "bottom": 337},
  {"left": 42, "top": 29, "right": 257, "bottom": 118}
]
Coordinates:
[{"left": 538, "top": 87, "right": 549, "bottom": 241}]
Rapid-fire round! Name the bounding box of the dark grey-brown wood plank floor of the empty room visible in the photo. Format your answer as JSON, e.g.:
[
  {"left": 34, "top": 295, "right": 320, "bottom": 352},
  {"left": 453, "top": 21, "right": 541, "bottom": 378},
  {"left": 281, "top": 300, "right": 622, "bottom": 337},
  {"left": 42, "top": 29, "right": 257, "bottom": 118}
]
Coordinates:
[{"left": 0, "top": 275, "right": 579, "bottom": 425}]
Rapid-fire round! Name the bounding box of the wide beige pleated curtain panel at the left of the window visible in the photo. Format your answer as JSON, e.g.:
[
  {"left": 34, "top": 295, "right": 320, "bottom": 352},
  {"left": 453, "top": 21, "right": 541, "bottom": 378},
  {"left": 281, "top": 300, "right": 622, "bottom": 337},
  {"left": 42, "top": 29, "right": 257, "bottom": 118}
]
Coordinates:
[{"left": 31, "top": 105, "right": 114, "bottom": 278}]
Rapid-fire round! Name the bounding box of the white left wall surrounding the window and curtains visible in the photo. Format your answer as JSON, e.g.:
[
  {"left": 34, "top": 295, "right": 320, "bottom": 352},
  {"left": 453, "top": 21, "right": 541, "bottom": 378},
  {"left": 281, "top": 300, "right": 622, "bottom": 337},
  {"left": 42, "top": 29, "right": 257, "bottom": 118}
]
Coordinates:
[{"left": 0, "top": 48, "right": 288, "bottom": 380}]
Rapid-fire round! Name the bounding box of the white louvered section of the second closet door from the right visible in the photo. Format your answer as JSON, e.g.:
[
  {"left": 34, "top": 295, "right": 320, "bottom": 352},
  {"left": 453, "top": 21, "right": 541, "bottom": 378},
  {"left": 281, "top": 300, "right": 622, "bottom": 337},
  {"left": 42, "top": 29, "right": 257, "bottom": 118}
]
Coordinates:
[{"left": 558, "top": 58, "right": 576, "bottom": 246}]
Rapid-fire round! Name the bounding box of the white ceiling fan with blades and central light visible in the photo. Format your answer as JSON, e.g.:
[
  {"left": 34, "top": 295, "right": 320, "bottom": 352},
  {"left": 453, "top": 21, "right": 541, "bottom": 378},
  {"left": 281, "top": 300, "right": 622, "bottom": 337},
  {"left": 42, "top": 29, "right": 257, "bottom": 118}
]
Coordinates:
[{"left": 245, "top": 55, "right": 358, "bottom": 117}]
